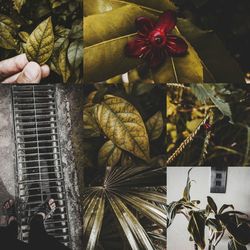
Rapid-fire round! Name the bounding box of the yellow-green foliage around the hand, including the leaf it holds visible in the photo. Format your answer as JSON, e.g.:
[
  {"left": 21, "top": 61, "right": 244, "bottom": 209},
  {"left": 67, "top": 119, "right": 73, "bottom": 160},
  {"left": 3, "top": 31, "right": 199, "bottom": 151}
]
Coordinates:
[{"left": 0, "top": 0, "right": 83, "bottom": 83}]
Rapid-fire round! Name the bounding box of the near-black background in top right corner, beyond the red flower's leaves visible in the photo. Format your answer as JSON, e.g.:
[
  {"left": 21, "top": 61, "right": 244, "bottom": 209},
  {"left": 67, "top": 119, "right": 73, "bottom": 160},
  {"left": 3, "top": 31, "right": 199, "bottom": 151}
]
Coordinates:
[{"left": 173, "top": 0, "right": 250, "bottom": 79}]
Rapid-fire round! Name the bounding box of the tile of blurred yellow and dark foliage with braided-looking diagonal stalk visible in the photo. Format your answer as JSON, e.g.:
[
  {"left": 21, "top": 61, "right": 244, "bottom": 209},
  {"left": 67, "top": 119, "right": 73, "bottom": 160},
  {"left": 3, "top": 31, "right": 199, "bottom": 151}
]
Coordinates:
[{"left": 167, "top": 84, "right": 250, "bottom": 166}]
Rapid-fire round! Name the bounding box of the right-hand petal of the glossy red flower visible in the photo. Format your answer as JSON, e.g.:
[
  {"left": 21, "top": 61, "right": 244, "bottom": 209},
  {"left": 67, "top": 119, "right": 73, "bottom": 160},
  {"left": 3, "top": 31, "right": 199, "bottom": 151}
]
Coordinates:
[{"left": 167, "top": 35, "right": 188, "bottom": 55}]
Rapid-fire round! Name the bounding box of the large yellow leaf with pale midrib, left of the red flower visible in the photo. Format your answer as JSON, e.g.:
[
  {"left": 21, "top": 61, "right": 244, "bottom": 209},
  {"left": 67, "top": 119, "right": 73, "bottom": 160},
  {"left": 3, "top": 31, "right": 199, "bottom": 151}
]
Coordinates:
[{"left": 84, "top": 5, "right": 153, "bottom": 83}]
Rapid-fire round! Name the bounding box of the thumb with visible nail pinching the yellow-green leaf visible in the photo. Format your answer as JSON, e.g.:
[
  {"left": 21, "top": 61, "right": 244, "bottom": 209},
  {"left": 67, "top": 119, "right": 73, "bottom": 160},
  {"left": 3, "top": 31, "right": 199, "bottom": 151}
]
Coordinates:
[{"left": 16, "top": 62, "right": 42, "bottom": 83}]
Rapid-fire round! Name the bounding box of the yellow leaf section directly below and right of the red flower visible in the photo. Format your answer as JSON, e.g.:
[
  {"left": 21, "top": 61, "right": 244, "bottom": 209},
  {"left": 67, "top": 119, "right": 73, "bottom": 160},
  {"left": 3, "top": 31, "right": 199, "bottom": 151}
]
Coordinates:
[{"left": 153, "top": 35, "right": 203, "bottom": 83}]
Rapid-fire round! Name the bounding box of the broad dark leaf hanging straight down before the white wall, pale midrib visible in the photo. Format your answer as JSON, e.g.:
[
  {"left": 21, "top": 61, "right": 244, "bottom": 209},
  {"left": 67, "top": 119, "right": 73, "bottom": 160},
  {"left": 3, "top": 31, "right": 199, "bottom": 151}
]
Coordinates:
[{"left": 188, "top": 211, "right": 206, "bottom": 249}]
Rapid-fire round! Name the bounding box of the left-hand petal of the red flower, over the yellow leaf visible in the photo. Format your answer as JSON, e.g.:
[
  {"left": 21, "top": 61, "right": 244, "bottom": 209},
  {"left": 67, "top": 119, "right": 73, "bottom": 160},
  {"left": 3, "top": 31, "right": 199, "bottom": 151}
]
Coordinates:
[{"left": 125, "top": 37, "right": 150, "bottom": 58}]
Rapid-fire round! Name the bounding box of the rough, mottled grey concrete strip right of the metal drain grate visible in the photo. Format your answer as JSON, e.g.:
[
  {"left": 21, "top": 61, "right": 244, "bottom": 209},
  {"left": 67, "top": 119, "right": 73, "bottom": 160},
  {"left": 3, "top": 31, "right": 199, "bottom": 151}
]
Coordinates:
[{"left": 56, "top": 84, "right": 83, "bottom": 250}]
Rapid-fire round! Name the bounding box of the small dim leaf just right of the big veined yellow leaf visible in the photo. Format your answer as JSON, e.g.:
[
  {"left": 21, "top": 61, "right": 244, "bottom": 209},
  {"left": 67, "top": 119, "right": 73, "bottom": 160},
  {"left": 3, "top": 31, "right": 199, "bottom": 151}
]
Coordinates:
[{"left": 146, "top": 111, "right": 163, "bottom": 140}]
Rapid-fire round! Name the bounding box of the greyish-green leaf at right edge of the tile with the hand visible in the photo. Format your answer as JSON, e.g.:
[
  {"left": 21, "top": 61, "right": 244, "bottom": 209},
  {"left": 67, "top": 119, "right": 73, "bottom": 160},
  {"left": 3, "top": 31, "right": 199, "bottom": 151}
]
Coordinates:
[{"left": 67, "top": 40, "right": 83, "bottom": 69}]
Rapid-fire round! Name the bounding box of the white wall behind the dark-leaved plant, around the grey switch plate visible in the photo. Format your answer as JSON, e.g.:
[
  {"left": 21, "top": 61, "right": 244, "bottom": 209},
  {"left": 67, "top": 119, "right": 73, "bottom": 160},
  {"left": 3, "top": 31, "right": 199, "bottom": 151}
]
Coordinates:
[{"left": 167, "top": 167, "right": 250, "bottom": 250}]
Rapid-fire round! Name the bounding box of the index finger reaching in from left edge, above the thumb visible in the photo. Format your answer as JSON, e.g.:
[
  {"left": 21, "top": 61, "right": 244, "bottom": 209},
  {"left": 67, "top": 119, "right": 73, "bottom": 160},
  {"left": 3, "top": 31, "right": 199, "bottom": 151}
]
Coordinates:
[{"left": 0, "top": 54, "right": 28, "bottom": 81}]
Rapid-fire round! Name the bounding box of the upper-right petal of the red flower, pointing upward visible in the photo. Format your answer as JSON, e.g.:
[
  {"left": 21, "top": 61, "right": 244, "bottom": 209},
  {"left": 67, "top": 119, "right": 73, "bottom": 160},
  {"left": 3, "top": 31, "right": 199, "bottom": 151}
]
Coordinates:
[{"left": 155, "top": 10, "right": 177, "bottom": 34}]
